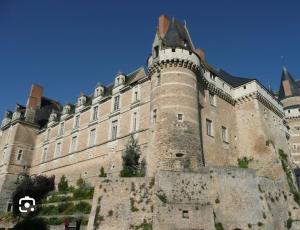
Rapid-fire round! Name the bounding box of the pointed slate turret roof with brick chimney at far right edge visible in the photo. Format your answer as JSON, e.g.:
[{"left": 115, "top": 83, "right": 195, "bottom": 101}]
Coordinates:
[{"left": 278, "top": 67, "right": 300, "bottom": 100}]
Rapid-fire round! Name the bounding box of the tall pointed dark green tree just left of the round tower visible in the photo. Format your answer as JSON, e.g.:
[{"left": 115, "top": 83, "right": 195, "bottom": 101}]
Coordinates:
[{"left": 120, "top": 135, "right": 146, "bottom": 177}]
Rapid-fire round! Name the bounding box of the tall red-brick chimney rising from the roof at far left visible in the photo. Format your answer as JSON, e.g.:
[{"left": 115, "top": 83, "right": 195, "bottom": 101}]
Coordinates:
[{"left": 25, "top": 84, "right": 43, "bottom": 123}]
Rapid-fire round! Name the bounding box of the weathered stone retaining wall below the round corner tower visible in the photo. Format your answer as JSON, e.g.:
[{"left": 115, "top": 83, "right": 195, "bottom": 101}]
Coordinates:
[{"left": 88, "top": 167, "right": 299, "bottom": 230}]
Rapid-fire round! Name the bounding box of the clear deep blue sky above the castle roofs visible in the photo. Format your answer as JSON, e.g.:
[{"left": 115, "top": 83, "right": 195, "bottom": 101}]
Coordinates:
[{"left": 0, "top": 0, "right": 300, "bottom": 117}]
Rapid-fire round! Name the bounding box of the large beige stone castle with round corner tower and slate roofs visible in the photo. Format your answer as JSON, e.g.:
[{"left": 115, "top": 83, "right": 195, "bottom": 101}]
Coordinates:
[{"left": 0, "top": 15, "right": 300, "bottom": 229}]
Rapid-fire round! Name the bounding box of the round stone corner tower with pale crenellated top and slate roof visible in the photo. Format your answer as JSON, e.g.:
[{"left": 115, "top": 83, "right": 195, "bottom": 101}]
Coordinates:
[{"left": 147, "top": 15, "right": 204, "bottom": 174}]
